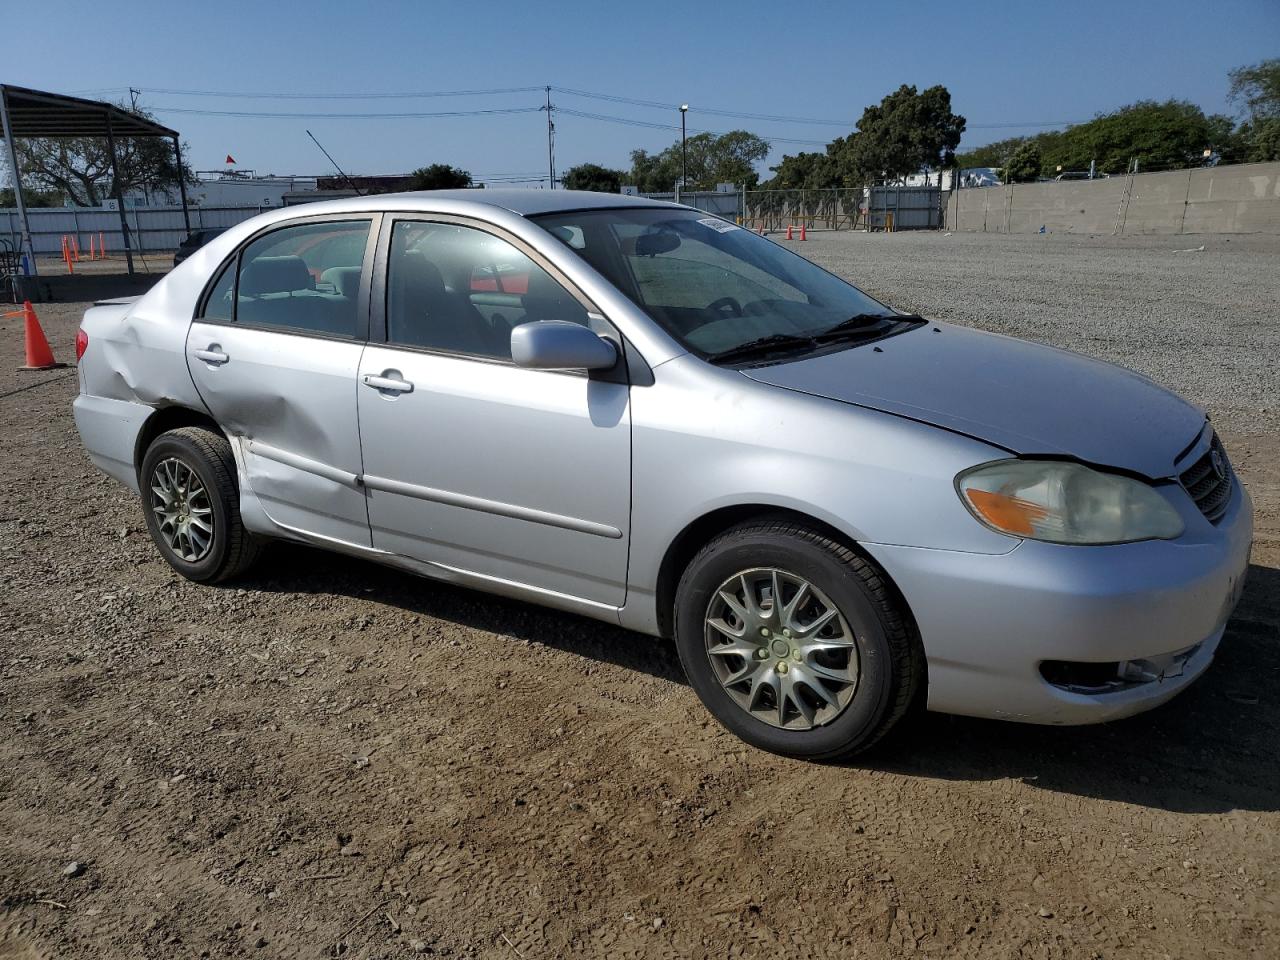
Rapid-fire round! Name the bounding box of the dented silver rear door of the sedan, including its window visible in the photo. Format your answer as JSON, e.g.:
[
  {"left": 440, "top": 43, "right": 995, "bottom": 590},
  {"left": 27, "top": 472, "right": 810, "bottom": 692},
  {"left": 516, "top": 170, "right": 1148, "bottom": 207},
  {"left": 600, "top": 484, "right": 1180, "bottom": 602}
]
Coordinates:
[{"left": 187, "top": 215, "right": 380, "bottom": 547}]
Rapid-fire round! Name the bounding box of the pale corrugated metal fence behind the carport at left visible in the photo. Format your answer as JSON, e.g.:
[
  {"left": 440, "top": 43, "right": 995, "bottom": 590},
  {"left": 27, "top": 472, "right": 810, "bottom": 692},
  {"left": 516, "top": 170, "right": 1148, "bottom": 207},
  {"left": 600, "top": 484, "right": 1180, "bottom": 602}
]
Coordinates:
[{"left": 0, "top": 206, "right": 276, "bottom": 255}]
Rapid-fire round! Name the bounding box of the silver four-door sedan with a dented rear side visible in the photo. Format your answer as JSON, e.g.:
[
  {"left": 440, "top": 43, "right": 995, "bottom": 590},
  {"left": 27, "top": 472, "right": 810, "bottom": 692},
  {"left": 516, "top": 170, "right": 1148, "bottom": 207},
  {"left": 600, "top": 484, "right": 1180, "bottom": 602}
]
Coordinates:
[{"left": 76, "top": 189, "right": 1252, "bottom": 759}]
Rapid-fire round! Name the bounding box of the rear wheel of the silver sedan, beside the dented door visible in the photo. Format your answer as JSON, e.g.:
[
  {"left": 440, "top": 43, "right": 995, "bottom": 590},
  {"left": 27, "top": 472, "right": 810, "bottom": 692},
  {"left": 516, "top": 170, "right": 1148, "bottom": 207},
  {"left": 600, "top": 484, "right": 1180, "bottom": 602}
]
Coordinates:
[{"left": 138, "top": 426, "right": 260, "bottom": 584}]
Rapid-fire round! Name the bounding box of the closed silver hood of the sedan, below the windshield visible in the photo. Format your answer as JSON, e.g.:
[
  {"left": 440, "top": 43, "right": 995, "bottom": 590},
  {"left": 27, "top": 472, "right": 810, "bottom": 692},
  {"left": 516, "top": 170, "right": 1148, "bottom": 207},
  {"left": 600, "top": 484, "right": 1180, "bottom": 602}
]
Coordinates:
[{"left": 742, "top": 323, "right": 1204, "bottom": 479}]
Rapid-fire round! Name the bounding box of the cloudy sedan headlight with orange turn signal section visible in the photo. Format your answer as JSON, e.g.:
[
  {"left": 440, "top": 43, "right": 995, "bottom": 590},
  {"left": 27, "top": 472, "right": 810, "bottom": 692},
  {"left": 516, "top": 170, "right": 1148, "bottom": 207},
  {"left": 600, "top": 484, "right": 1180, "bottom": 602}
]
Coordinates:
[{"left": 956, "top": 460, "right": 1183, "bottom": 544}]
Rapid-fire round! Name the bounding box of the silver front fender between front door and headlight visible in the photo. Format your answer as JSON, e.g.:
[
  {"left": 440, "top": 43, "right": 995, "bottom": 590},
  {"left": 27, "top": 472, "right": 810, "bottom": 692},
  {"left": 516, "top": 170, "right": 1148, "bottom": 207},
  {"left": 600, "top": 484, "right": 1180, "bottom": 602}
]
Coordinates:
[{"left": 627, "top": 356, "right": 1018, "bottom": 632}]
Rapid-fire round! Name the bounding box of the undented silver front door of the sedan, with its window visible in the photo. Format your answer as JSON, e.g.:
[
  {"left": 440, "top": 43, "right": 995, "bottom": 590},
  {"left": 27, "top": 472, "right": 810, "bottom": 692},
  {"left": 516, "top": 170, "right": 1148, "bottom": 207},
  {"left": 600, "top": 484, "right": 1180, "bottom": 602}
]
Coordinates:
[{"left": 358, "top": 219, "right": 631, "bottom": 605}]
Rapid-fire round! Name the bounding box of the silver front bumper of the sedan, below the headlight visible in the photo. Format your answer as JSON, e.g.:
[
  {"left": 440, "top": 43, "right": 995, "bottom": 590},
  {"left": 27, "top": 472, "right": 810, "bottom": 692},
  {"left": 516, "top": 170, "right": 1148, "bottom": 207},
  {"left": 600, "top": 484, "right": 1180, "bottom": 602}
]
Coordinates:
[{"left": 864, "top": 480, "right": 1253, "bottom": 724}]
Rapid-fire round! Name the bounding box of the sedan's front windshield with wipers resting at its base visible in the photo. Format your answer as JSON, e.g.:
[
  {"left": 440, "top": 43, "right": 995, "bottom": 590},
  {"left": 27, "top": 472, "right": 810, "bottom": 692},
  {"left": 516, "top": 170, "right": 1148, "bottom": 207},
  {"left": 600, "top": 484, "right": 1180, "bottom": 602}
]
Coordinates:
[{"left": 532, "top": 207, "right": 897, "bottom": 360}]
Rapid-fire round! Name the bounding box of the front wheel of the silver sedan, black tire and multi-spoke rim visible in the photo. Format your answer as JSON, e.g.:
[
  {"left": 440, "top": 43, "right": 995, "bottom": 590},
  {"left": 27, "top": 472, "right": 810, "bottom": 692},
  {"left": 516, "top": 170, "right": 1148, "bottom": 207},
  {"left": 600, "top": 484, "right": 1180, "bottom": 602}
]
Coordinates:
[{"left": 675, "top": 520, "right": 925, "bottom": 760}]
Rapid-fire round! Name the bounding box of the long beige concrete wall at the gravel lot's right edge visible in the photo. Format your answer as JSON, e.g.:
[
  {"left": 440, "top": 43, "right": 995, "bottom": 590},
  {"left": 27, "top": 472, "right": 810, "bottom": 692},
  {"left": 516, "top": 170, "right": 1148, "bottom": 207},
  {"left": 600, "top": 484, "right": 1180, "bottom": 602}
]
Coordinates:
[{"left": 946, "top": 163, "right": 1280, "bottom": 234}]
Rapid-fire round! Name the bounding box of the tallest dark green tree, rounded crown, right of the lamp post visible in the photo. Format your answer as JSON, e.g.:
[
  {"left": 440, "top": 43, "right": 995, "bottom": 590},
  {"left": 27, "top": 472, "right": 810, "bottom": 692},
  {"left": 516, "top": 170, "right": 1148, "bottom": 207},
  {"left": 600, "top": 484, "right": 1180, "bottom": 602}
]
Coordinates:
[{"left": 827, "top": 84, "right": 965, "bottom": 187}]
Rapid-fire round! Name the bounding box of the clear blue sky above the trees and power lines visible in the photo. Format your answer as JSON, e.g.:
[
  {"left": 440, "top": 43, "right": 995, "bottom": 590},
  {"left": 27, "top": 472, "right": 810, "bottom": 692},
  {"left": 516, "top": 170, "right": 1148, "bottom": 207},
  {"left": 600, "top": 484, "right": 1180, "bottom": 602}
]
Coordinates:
[{"left": 0, "top": 0, "right": 1280, "bottom": 184}]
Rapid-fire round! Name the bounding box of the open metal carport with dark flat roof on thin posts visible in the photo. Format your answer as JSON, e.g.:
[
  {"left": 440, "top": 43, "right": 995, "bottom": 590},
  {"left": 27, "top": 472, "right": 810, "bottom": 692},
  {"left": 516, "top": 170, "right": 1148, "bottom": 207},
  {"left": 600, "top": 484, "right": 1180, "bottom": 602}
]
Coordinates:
[{"left": 0, "top": 83, "right": 191, "bottom": 276}]
